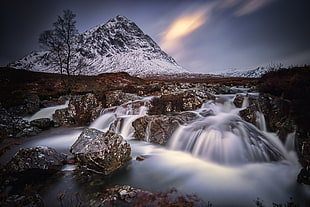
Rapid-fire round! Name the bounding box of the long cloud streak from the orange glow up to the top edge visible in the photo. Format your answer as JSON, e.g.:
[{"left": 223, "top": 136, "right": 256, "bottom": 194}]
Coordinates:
[{"left": 159, "top": 0, "right": 275, "bottom": 55}]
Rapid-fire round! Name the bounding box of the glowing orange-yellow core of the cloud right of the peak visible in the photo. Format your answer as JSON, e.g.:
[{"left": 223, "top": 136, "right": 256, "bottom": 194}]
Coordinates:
[{"left": 160, "top": 6, "right": 210, "bottom": 52}]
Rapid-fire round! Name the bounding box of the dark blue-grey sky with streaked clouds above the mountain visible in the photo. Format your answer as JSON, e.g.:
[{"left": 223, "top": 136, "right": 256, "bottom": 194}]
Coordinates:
[{"left": 0, "top": 0, "right": 310, "bottom": 73}]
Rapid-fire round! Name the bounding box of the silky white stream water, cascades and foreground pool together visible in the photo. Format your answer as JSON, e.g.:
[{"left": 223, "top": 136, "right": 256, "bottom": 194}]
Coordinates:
[{"left": 1, "top": 95, "right": 310, "bottom": 207}]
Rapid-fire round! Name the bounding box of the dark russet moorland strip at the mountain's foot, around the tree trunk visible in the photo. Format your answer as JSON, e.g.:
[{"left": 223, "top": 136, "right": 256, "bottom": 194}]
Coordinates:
[{"left": 0, "top": 68, "right": 144, "bottom": 107}]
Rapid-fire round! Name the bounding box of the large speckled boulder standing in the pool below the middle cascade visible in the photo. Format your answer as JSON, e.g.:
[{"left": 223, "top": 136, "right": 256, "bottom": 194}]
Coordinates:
[{"left": 70, "top": 128, "right": 131, "bottom": 175}]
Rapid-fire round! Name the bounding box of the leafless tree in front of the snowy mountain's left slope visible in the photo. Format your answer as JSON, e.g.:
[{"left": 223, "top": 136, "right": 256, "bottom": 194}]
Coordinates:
[{"left": 39, "top": 9, "right": 85, "bottom": 92}]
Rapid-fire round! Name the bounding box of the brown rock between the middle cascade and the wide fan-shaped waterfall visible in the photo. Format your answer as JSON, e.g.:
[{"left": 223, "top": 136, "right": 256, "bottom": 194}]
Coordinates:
[{"left": 132, "top": 112, "right": 198, "bottom": 145}]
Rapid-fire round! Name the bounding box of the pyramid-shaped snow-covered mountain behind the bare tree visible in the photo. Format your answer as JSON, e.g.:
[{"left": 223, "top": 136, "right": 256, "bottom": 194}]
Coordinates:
[{"left": 8, "top": 16, "right": 188, "bottom": 77}]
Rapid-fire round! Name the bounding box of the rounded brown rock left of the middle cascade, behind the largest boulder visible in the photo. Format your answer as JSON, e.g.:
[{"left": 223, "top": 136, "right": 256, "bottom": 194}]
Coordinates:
[{"left": 68, "top": 93, "right": 103, "bottom": 125}]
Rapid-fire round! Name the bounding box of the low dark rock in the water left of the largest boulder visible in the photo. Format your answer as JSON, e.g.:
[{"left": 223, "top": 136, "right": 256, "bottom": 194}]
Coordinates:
[{"left": 5, "top": 146, "right": 66, "bottom": 173}]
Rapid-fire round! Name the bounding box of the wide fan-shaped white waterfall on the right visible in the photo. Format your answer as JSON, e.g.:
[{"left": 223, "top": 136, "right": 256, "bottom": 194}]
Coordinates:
[{"left": 169, "top": 100, "right": 287, "bottom": 164}]
